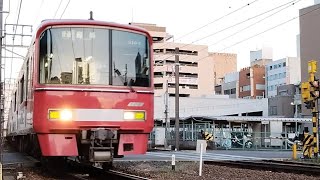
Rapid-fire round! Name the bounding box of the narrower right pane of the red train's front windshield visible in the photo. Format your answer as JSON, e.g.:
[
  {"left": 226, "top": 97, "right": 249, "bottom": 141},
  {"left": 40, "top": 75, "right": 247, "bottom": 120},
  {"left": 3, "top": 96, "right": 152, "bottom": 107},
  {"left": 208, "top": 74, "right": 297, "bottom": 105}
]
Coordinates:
[{"left": 112, "top": 30, "right": 150, "bottom": 87}]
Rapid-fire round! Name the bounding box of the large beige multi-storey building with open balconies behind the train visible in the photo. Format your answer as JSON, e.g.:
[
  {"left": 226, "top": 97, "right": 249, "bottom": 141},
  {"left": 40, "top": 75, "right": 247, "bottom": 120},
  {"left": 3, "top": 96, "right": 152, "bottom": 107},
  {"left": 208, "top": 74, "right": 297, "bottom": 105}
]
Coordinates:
[{"left": 131, "top": 23, "right": 237, "bottom": 97}]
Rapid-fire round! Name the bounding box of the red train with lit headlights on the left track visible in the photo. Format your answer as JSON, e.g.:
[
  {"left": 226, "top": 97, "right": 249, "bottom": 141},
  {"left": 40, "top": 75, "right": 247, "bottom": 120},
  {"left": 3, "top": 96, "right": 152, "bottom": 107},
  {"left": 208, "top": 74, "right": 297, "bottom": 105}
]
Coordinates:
[{"left": 8, "top": 20, "right": 154, "bottom": 167}]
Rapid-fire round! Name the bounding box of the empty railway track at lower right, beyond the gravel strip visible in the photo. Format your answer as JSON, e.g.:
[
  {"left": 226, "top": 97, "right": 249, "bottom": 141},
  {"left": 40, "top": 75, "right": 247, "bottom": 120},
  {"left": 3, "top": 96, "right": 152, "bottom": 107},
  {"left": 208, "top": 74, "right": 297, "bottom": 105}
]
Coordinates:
[{"left": 204, "top": 160, "right": 320, "bottom": 176}]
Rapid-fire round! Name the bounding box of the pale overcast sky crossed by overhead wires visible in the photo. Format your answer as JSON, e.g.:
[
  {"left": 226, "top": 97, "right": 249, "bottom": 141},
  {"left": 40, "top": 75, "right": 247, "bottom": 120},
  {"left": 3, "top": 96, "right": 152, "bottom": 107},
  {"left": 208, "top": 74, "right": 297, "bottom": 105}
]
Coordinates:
[{"left": 3, "top": 0, "right": 314, "bottom": 81}]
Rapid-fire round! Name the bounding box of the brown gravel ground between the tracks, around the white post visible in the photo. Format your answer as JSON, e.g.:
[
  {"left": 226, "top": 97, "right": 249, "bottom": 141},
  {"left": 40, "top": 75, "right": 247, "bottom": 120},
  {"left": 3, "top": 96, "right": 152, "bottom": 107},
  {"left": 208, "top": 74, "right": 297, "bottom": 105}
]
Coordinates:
[{"left": 114, "top": 162, "right": 320, "bottom": 180}]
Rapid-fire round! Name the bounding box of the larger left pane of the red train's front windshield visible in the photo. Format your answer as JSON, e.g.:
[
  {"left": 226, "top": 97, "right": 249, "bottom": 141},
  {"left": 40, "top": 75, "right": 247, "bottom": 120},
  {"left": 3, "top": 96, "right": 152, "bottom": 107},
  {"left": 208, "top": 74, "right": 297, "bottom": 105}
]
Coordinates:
[{"left": 39, "top": 27, "right": 110, "bottom": 85}]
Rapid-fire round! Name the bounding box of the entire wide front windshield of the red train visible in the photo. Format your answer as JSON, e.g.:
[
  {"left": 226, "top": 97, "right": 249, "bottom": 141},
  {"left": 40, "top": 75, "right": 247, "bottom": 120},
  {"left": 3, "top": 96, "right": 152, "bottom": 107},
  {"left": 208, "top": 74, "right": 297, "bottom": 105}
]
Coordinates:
[{"left": 39, "top": 27, "right": 151, "bottom": 87}]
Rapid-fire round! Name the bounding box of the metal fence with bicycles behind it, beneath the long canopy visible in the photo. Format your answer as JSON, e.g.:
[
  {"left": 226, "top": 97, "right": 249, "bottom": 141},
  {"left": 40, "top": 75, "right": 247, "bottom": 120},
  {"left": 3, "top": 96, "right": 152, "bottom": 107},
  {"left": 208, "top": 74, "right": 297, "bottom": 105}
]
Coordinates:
[{"left": 149, "top": 123, "right": 299, "bottom": 150}]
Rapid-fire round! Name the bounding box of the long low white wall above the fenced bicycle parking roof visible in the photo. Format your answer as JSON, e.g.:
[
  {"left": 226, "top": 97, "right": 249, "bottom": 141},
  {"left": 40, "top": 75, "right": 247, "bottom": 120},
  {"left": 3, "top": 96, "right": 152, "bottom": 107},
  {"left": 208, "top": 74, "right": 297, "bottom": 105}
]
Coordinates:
[{"left": 154, "top": 95, "right": 268, "bottom": 119}]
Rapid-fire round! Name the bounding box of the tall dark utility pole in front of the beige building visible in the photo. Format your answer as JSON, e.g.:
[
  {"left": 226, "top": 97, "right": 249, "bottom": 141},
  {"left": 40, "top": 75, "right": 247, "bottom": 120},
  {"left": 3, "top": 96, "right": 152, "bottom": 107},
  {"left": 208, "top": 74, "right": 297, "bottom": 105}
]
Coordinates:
[{"left": 175, "top": 48, "right": 180, "bottom": 151}]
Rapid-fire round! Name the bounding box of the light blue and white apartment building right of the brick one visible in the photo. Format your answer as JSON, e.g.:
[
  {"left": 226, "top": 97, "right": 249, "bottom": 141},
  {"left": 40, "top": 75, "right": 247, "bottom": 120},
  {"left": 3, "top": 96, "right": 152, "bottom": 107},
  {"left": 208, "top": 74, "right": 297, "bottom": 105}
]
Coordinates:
[{"left": 266, "top": 57, "right": 301, "bottom": 98}]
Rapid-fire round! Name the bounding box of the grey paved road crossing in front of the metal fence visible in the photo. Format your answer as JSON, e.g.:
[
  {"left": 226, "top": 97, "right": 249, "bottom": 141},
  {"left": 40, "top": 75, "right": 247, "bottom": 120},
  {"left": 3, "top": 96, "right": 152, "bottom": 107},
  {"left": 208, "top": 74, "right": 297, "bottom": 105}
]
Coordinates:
[{"left": 115, "top": 150, "right": 298, "bottom": 161}]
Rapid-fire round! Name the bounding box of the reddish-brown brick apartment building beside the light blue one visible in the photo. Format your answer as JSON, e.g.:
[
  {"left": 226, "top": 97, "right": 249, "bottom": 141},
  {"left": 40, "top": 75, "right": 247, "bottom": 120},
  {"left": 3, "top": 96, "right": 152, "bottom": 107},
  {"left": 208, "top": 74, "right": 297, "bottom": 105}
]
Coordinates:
[{"left": 239, "top": 65, "right": 265, "bottom": 99}]
